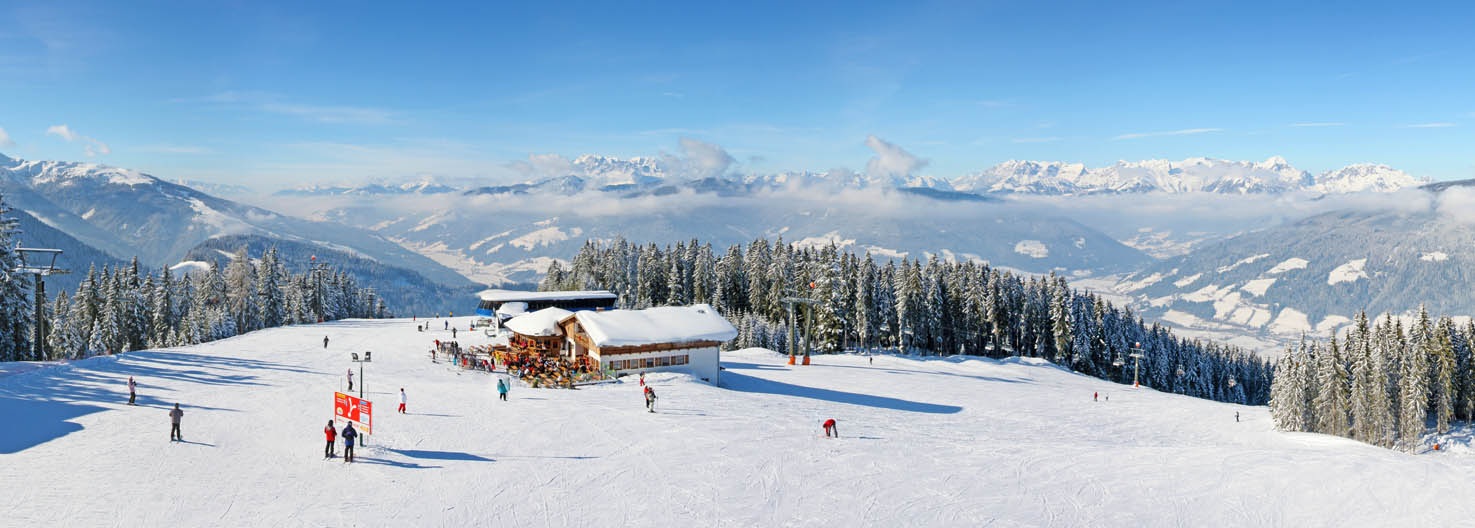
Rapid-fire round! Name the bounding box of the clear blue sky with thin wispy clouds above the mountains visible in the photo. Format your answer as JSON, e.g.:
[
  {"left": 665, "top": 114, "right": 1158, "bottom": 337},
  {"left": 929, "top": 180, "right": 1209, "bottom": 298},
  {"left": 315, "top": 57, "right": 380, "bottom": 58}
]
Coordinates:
[{"left": 0, "top": 1, "right": 1475, "bottom": 187}]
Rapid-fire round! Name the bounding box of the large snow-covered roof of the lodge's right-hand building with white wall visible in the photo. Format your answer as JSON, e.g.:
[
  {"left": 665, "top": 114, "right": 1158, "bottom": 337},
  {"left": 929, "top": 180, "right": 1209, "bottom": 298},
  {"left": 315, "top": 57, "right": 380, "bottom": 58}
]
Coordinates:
[{"left": 565, "top": 304, "right": 738, "bottom": 347}]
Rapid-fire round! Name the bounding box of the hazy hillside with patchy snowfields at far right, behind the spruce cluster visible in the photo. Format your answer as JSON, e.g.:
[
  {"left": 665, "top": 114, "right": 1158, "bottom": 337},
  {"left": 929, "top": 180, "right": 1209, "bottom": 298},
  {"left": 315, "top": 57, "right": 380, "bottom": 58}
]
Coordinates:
[{"left": 1118, "top": 196, "right": 1475, "bottom": 336}]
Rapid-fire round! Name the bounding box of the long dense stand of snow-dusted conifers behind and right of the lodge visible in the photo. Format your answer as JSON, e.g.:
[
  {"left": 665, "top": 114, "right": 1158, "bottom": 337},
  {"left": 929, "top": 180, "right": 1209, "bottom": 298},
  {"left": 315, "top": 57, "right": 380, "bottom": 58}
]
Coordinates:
[{"left": 540, "top": 239, "right": 1271, "bottom": 404}]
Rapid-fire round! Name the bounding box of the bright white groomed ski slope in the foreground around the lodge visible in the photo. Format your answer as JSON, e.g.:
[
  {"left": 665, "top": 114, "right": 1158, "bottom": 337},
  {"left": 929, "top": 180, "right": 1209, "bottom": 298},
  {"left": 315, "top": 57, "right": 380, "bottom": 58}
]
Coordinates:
[{"left": 0, "top": 319, "right": 1475, "bottom": 527}]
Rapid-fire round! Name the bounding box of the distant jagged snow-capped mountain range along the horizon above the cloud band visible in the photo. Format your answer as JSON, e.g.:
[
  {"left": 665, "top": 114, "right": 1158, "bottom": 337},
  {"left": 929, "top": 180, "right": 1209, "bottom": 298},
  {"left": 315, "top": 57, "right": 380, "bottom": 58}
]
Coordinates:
[{"left": 268, "top": 155, "right": 1429, "bottom": 196}]
